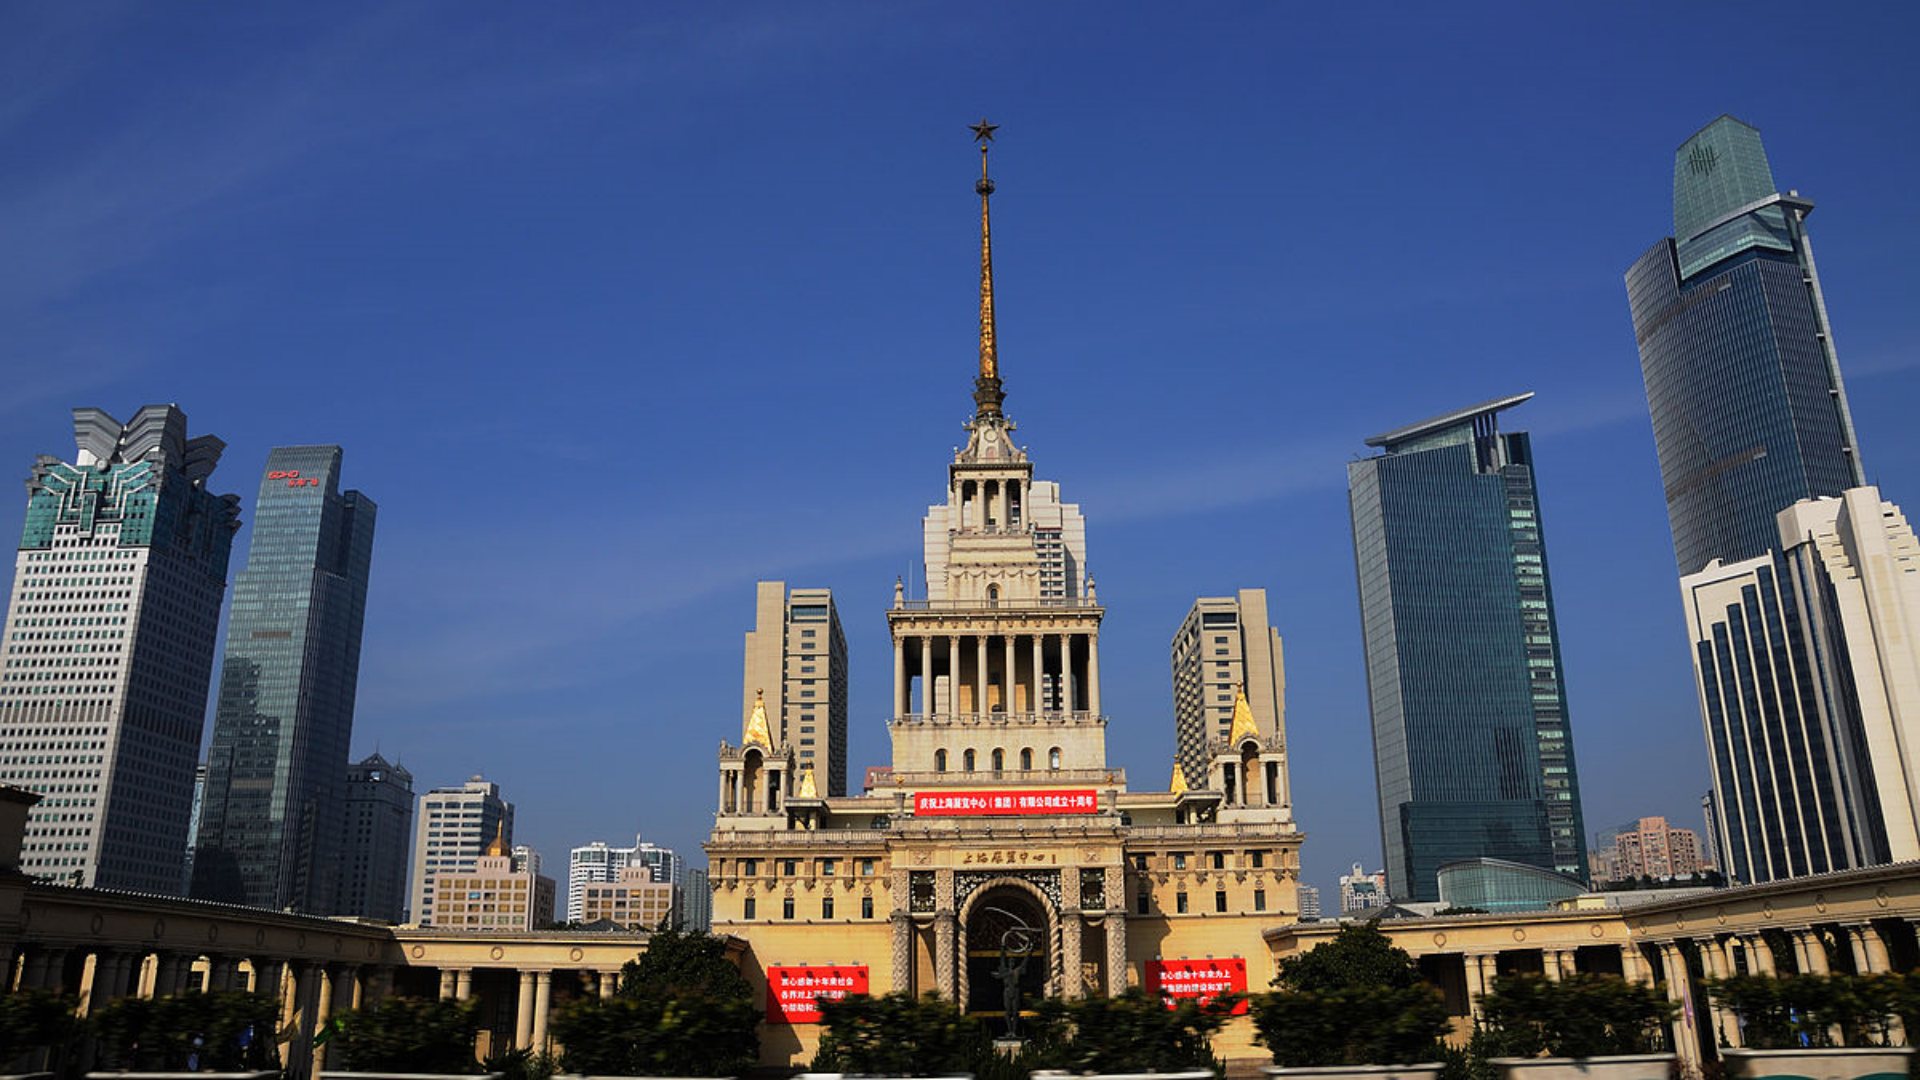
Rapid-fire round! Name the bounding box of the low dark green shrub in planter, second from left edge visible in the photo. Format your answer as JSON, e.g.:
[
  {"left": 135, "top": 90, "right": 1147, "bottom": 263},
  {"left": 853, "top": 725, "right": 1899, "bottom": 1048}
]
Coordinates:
[{"left": 88, "top": 990, "right": 280, "bottom": 1070}]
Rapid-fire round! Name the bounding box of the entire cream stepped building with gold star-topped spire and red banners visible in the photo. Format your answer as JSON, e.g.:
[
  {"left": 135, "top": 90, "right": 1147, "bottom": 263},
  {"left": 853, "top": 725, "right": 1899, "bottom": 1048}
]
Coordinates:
[{"left": 707, "top": 127, "right": 1302, "bottom": 1065}]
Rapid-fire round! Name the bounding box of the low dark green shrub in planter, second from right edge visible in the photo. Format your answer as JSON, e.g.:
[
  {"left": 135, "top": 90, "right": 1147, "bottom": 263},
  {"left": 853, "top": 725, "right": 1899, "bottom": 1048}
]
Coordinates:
[{"left": 1480, "top": 974, "right": 1676, "bottom": 1057}]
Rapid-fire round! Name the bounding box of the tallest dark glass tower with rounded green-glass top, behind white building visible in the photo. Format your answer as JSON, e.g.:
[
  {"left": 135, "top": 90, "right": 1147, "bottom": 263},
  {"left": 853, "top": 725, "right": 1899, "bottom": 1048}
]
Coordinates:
[{"left": 1626, "top": 115, "right": 1866, "bottom": 575}]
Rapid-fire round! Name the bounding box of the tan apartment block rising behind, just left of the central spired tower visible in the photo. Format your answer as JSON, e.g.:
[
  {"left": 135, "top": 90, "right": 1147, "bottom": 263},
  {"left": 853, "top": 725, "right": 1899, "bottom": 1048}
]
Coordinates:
[{"left": 741, "top": 580, "right": 847, "bottom": 798}]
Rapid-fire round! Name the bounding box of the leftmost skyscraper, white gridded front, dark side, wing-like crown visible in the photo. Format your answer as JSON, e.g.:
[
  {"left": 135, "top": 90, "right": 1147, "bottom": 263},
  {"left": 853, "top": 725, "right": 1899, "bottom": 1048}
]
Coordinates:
[{"left": 0, "top": 405, "right": 240, "bottom": 896}]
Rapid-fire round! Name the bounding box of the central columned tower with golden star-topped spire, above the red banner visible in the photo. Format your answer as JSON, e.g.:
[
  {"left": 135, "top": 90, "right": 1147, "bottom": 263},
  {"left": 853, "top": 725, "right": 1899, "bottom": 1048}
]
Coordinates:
[{"left": 887, "top": 121, "right": 1106, "bottom": 768}]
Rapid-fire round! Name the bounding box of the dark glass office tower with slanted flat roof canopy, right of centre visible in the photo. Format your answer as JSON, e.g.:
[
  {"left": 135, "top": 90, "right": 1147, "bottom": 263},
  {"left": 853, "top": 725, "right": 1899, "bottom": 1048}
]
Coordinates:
[{"left": 1348, "top": 394, "right": 1586, "bottom": 901}]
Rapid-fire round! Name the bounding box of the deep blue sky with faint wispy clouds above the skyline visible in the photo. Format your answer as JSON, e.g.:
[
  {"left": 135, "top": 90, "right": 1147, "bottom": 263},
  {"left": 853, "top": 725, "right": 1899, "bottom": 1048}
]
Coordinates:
[{"left": 0, "top": 4, "right": 1920, "bottom": 886}]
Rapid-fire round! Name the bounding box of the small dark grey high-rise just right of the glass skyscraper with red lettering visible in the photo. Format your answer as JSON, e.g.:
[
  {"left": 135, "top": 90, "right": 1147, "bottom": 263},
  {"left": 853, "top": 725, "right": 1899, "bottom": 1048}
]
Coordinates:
[{"left": 334, "top": 753, "right": 413, "bottom": 922}]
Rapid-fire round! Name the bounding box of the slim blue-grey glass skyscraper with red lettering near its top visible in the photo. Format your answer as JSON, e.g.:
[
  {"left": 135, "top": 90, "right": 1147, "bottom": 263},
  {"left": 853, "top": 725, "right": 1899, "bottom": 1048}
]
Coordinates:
[{"left": 194, "top": 446, "right": 376, "bottom": 915}]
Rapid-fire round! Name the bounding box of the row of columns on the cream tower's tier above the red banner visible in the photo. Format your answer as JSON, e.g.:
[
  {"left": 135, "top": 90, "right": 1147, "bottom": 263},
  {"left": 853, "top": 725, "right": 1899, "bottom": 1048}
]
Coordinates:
[{"left": 893, "top": 630, "right": 1100, "bottom": 719}]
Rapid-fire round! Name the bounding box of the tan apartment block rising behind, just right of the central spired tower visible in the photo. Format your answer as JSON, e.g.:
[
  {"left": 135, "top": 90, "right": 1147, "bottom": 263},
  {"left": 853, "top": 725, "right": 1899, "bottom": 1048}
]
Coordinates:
[{"left": 1171, "top": 588, "right": 1286, "bottom": 786}]
